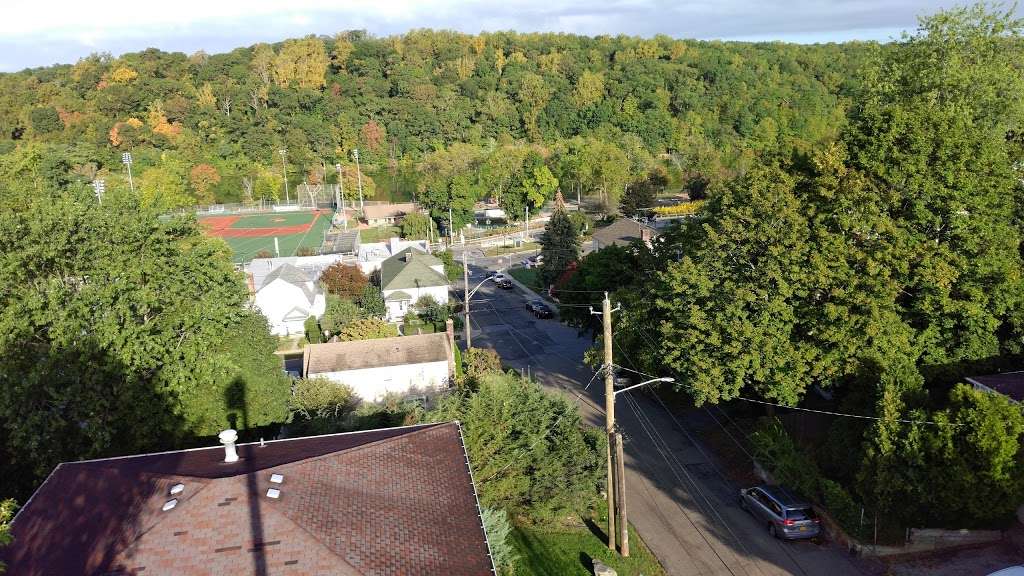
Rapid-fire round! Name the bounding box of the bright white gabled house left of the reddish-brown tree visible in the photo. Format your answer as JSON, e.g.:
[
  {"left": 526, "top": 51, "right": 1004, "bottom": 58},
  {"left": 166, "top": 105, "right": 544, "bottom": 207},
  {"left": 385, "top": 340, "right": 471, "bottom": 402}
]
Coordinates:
[{"left": 253, "top": 263, "right": 327, "bottom": 336}]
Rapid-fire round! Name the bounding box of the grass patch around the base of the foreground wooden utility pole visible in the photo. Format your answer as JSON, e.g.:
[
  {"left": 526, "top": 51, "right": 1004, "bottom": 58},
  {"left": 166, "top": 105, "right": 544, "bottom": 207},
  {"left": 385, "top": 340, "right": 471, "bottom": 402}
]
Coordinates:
[{"left": 512, "top": 508, "right": 665, "bottom": 576}]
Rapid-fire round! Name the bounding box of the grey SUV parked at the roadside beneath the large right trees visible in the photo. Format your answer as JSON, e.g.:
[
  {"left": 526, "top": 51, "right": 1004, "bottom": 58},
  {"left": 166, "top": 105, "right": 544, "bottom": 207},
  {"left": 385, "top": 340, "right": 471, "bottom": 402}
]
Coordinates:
[{"left": 739, "top": 485, "right": 821, "bottom": 540}]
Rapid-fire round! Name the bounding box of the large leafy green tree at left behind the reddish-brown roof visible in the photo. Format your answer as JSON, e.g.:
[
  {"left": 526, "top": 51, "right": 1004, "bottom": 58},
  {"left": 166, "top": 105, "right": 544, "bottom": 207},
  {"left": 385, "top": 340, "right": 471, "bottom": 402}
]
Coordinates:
[{"left": 0, "top": 191, "right": 272, "bottom": 494}]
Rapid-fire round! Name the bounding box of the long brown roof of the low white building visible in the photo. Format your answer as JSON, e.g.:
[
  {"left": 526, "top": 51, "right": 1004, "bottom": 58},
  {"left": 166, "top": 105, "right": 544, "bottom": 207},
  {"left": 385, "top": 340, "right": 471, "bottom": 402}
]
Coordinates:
[{"left": 302, "top": 332, "right": 453, "bottom": 375}]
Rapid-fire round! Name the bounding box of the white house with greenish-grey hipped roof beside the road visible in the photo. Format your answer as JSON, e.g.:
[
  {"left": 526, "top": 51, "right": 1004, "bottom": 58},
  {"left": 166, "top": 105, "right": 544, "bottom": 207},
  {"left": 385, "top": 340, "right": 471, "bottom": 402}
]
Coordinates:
[{"left": 381, "top": 247, "right": 449, "bottom": 322}]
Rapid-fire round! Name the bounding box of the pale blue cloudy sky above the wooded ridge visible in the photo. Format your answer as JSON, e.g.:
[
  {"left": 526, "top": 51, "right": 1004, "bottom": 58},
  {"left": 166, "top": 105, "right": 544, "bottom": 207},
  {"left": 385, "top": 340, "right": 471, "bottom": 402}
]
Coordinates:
[{"left": 0, "top": 0, "right": 955, "bottom": 72}]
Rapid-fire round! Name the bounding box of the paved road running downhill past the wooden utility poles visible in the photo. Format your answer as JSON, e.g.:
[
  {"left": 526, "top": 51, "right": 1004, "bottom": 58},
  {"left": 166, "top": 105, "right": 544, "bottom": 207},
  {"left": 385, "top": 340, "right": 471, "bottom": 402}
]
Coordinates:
[{"left": 460, "top": 256, "right": 873, "bottom": 576}]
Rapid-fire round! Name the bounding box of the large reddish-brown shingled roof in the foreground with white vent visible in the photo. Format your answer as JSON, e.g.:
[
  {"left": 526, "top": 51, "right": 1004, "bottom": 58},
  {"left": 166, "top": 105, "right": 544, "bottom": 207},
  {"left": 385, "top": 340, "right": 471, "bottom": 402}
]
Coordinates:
[{"left": 0, "top": 423, "right": 493, "bottom": 576}]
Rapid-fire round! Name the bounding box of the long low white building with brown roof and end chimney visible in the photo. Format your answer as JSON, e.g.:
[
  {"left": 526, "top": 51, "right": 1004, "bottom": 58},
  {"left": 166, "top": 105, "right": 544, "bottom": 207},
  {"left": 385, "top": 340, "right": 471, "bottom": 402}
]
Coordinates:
[{"left": 302, "top": 330, "right": 455, "bottom": 402}]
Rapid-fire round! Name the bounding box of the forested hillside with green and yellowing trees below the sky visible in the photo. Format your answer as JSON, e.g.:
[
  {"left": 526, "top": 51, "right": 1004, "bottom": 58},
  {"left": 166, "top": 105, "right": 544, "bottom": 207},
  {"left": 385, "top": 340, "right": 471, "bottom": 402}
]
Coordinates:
[{"left": 0, "top": 30, "right": 882, "bottom": 220}]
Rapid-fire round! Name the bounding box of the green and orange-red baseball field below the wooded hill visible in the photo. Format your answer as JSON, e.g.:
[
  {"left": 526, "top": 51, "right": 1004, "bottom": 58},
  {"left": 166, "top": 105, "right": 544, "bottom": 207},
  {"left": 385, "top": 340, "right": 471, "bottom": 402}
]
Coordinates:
[{"left": 199, "top": 211, "right": 331, "bottom": 262}]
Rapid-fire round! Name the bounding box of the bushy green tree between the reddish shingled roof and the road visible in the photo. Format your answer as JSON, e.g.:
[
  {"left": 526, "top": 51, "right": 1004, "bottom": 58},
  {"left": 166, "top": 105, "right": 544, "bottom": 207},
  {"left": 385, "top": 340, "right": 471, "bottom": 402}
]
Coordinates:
[{"left": 426, "top": 373, "right": 604, "bottom": 521}]
